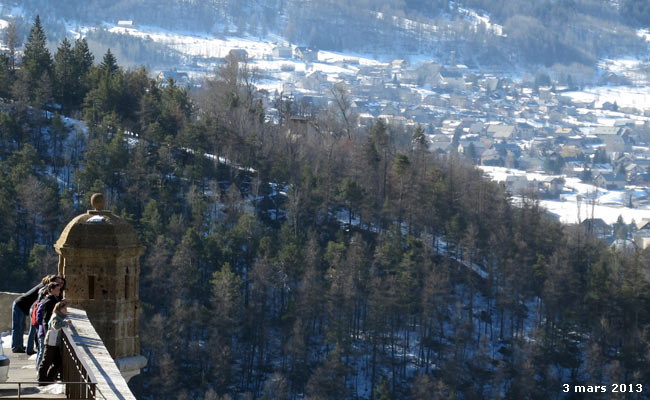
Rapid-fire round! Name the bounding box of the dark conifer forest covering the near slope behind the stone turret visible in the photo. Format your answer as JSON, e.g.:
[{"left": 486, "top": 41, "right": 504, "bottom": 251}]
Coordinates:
[{"left": 0, "top": 18, "right": 650, "bottom": 400}]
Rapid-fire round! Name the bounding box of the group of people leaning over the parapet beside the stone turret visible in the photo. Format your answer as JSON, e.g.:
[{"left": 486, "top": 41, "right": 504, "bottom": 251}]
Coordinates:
[{"left": 11, "top": 275, "right": 70, "bottom": 384}]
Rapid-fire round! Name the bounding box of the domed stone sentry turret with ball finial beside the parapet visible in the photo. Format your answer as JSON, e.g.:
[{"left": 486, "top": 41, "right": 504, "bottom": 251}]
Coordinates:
[{"left": 54, "top": 193, "right": 146, "bottom": 382}]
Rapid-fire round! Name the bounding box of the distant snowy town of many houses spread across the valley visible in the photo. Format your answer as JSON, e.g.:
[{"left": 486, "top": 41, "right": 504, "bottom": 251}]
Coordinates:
[{"left": 142, "top": 32, "right": 650, "bottom": 248}]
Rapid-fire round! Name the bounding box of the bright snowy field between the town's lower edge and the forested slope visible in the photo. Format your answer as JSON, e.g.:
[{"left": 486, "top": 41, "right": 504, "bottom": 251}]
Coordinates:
[{"left": 480, "top": 166, "right": 650, "bottom": 224}]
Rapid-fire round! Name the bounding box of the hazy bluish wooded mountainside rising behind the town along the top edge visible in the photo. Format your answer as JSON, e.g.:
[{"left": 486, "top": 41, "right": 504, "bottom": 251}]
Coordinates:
[{"left": 0, "top": 0, "right": 644, "bottom": 68}]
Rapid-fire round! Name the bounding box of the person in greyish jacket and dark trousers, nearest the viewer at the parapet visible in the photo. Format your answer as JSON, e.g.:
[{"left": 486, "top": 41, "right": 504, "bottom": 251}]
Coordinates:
[{"left": 38, "top": 300, "right": 70, "bottom": 384}]
